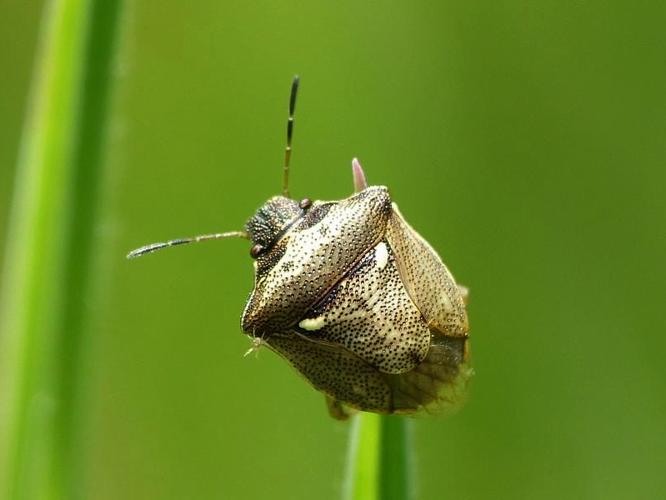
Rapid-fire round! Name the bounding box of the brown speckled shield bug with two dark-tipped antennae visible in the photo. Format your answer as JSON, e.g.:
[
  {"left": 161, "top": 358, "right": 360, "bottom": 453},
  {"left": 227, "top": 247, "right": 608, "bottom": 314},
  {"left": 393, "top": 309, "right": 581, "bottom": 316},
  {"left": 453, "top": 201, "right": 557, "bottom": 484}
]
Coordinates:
[{"left": 127, "top": 77, "right": 472, "bottom": 419}]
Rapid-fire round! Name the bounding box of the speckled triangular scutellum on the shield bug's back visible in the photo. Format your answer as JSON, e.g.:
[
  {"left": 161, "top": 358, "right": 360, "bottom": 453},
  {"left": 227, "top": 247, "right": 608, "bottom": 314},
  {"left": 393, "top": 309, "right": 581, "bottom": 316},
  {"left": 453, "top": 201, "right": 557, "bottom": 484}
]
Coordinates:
[{"left": 304, "top": 242, "right": 430, "bottom": 373}]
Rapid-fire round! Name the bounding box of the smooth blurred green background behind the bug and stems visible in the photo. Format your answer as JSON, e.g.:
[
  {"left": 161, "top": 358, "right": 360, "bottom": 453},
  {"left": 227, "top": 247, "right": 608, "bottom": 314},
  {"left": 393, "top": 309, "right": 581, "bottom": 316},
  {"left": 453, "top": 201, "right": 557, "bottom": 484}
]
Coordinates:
[{"left": 0, "top": 0, "right": 666, "bottom": 500}]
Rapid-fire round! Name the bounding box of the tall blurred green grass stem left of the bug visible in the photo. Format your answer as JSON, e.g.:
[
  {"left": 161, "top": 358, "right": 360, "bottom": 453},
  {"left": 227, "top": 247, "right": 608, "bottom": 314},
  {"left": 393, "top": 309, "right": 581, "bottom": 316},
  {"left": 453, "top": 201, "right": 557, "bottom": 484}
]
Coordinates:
[{"left": 0, "top": 0, "right": 119, "bottom": 500}]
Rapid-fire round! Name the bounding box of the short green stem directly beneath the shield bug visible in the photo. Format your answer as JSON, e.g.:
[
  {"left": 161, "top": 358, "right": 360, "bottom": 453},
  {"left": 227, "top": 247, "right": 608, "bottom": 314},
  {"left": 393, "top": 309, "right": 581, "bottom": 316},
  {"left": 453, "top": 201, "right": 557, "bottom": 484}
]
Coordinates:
[{"left": 343, "top": 413, "right": 413, "bottom": 500}]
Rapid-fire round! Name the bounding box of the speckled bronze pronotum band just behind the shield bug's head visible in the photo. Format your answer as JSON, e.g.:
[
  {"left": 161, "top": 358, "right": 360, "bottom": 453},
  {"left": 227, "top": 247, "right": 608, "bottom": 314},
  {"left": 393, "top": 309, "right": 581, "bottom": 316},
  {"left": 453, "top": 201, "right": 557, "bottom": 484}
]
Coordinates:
[{"left": 241, "top": 186, "right": 391, "bottom": 336}]
